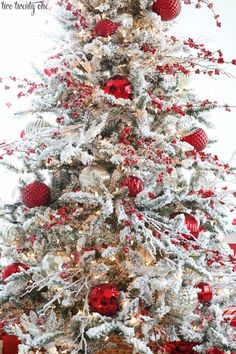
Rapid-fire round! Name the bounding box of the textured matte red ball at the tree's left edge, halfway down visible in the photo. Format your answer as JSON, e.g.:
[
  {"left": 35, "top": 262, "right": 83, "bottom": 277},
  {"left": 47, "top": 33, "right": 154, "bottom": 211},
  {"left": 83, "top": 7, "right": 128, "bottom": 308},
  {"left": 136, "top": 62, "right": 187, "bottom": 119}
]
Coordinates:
[{"left": 21, "top": 181, "right": 51, "bottom": 208}]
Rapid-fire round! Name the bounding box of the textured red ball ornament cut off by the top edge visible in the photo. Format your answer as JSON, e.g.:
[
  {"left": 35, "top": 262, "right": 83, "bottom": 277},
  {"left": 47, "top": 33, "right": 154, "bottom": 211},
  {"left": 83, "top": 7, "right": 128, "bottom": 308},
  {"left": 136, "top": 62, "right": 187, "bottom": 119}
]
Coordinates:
[{"left": 152, "top": 0, "right": 181, "bottom": 21}]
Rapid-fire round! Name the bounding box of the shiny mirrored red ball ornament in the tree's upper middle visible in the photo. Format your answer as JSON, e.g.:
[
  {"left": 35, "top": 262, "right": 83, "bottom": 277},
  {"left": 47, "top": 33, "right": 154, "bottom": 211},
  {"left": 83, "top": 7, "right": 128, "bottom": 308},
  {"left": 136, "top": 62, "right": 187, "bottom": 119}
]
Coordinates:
[{"left": 103, "top": 75, "right": 132, "bottom": 99}]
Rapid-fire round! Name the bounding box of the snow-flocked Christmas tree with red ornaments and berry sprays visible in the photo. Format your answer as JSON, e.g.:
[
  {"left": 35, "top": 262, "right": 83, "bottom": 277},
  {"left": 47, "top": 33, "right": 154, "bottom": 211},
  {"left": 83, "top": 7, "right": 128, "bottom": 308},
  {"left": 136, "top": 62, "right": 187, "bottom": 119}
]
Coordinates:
[{"left": 0, "top": 0, "right": 236, "bottom": 354}]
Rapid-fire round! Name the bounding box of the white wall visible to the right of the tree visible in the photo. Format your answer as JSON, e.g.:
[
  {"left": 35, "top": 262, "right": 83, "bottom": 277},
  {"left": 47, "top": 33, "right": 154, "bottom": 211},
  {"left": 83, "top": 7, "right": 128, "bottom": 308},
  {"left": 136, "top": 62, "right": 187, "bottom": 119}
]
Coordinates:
[{"left": 173, "top": 0, "right": 236, "bottom": 166}]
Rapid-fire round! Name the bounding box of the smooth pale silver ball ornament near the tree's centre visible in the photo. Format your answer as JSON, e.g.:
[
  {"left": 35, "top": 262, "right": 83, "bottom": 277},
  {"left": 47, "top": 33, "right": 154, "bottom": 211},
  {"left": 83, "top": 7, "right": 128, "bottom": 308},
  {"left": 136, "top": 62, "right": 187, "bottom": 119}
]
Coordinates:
[{"left": 79, "top": 165, "right": 111, "bottom": 187}]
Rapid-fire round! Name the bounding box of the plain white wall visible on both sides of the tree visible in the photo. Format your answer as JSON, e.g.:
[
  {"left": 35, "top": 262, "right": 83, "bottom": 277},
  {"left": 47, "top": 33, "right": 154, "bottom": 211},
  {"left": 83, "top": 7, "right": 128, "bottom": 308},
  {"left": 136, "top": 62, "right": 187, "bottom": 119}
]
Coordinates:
[{"left": 0, "top": 0, "right": 236, "bottom": 209}]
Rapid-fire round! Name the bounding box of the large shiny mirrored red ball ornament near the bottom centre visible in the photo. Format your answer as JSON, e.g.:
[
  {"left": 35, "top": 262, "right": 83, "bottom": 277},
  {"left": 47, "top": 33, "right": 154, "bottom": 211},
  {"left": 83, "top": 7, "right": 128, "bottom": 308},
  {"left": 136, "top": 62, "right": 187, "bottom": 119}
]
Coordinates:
[{"left": 88, "top": 283, "right": 119, "bottom": 316}]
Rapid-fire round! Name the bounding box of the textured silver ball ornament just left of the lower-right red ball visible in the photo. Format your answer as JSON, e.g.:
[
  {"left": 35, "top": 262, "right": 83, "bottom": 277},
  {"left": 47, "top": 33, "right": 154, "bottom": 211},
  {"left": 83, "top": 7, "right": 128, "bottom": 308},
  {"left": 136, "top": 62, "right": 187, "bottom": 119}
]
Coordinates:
[{"left": 166, "top": 286, "right": 198, "bottom": 317}]
